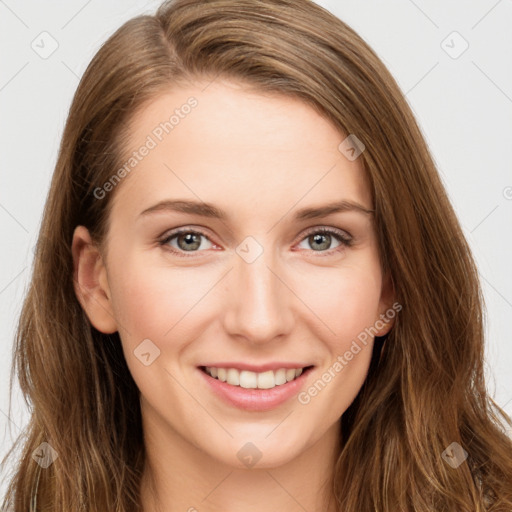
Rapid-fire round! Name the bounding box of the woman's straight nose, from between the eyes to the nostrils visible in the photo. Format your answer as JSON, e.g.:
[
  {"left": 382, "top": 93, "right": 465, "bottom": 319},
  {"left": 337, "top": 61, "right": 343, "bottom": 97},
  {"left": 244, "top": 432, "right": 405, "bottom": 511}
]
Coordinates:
[{"left": 224, "top": 243, "right": 295, "bottom": 344}]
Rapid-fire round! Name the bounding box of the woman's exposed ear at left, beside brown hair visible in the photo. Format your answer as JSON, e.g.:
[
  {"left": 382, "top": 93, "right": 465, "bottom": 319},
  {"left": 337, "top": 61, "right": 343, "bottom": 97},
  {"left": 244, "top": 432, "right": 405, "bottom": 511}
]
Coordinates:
[{"left": 71, "top": 226, "right": 117, "bottom": 334}]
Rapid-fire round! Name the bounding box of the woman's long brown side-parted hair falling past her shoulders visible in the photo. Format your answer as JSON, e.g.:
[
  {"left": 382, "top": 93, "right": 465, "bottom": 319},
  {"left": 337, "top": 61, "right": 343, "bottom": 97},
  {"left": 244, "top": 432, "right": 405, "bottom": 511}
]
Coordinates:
[{"left": 4, "top": 0, "right": 512, "bottom": 512}]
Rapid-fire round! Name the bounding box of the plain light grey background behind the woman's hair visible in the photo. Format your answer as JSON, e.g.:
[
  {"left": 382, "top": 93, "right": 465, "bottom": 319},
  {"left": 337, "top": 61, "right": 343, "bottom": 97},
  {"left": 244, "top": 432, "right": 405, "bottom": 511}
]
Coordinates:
[{"left": 0, "top": 0, "right": 512, "bottom": 496}]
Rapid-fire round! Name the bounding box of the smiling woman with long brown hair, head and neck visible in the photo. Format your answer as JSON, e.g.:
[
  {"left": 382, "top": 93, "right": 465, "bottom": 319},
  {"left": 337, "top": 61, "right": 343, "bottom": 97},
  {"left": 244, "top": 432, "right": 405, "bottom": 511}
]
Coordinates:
[{"left": 1, "top": 0, "right": 512, "bottom": 512}]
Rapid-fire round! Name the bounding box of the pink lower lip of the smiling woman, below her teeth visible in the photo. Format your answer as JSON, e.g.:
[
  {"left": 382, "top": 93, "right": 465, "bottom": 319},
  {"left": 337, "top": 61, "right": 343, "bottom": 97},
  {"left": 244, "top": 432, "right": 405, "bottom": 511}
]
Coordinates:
[{"left": 198, "top": 367, "right": 313, "bottom": 411}]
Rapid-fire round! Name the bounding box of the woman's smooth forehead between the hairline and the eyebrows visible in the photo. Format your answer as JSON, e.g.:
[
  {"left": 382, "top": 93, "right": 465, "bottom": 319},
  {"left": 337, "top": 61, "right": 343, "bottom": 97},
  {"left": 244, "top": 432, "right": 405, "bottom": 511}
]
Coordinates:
[{"left": 109, "top": 81, "right": 371, "bottom": 221}]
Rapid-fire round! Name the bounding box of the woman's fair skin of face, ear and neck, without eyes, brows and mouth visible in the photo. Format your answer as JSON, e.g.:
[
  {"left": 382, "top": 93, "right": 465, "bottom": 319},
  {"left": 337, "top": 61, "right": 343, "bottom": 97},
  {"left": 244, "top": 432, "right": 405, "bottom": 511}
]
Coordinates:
[{"left": 72, "top": 80, "right": 394, "bottom": 512}]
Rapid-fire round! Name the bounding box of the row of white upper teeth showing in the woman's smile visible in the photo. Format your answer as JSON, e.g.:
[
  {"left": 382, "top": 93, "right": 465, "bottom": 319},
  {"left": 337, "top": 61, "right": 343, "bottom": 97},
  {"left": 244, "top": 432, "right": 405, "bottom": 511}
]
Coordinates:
[{"left": 206, "top": 366, "right": 303, "bottom": 389}]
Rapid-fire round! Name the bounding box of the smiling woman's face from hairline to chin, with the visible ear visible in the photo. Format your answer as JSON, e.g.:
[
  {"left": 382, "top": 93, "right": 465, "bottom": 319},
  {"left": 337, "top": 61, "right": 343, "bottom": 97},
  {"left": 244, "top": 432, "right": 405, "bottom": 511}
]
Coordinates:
[{"left": 73, "top": 81, "right": 392, "bottom": 467}]
